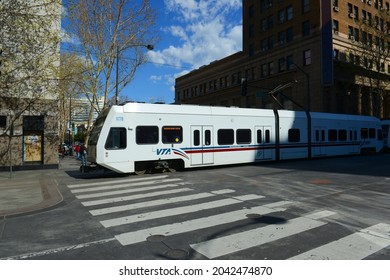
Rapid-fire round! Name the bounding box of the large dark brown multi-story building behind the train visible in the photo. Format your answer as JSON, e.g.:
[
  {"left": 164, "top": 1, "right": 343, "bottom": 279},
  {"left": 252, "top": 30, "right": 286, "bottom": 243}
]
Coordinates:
[{"left": 175, "top": 0, "right": 390, "bottom": 118}]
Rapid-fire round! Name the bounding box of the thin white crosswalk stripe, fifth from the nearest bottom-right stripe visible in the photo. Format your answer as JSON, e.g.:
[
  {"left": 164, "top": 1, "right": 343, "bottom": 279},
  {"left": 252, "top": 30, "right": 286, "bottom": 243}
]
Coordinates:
[{"left": 89, "top": 190, "right": 233, "bottom": 216}]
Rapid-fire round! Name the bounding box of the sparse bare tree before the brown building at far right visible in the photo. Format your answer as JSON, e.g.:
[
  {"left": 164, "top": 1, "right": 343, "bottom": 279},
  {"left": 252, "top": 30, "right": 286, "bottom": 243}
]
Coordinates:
[{"left": 349, "top": 10, "right": 390, "bottom": 118}]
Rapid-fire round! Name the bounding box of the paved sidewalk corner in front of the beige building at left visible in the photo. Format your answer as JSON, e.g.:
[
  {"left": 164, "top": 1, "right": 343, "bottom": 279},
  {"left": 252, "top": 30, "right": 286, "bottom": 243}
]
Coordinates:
[{"left": 0, "top": 157, "right": 77, "bottom": 217}]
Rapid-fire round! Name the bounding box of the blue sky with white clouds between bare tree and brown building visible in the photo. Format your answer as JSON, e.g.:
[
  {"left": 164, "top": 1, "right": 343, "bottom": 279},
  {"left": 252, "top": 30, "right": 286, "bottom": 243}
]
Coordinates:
[{"left": 61, "top": 0, "right": 242, "bottom": 103}]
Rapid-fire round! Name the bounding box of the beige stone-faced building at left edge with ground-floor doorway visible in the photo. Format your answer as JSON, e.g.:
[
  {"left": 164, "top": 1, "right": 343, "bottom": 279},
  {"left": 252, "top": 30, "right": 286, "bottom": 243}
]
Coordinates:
[{"left": 0, "top": 0, "right": 62, "bottom": 170}]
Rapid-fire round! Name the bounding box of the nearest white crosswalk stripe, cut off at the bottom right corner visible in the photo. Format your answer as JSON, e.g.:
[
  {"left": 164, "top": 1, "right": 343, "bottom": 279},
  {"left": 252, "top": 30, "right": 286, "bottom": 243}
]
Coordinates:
[{"left": 290, "top": 223, "right": 390, "bottom": 260}]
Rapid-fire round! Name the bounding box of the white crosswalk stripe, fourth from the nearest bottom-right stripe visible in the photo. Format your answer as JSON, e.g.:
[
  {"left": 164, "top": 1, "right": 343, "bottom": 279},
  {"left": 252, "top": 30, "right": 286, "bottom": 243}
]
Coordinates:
[{"left": 100, "top": 195, "right": 263, "bottom": 228}]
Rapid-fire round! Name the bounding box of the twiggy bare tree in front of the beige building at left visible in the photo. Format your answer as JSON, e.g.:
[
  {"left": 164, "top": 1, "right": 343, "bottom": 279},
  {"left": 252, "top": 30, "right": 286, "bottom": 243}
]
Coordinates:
[{"left": 0, "top": 0, "right": 61, "bottom": 171}]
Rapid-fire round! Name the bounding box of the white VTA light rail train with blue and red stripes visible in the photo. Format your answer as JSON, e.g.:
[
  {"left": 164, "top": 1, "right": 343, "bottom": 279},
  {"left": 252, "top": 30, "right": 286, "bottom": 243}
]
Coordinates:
[{"left": 87, "top": 103, "right": 383, "bottom": 173}]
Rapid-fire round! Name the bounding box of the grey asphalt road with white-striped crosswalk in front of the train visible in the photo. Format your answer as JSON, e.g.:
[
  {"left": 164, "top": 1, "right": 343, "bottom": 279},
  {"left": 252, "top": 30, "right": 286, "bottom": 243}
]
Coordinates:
[{"left": 0, "top": 154, "right": 390, "bottom": 260}]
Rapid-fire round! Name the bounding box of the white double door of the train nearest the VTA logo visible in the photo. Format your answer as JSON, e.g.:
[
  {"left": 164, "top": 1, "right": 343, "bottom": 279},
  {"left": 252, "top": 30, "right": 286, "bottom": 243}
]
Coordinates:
[{"left": 191, "top": 125, "right": 214, "bottom": 165}]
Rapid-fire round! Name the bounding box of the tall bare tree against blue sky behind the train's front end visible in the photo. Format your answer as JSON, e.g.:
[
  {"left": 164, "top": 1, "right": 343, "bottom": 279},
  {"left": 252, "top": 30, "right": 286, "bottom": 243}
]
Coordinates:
[{"left": 66, "top": 0, "right": 156, "bottom": 127}]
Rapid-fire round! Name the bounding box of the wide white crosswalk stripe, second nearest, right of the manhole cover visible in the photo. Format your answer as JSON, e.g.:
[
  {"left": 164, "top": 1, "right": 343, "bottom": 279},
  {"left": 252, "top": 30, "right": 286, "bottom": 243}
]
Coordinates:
[{"left": 190, "top": 211, "right": 334, "bottom": 259}]
